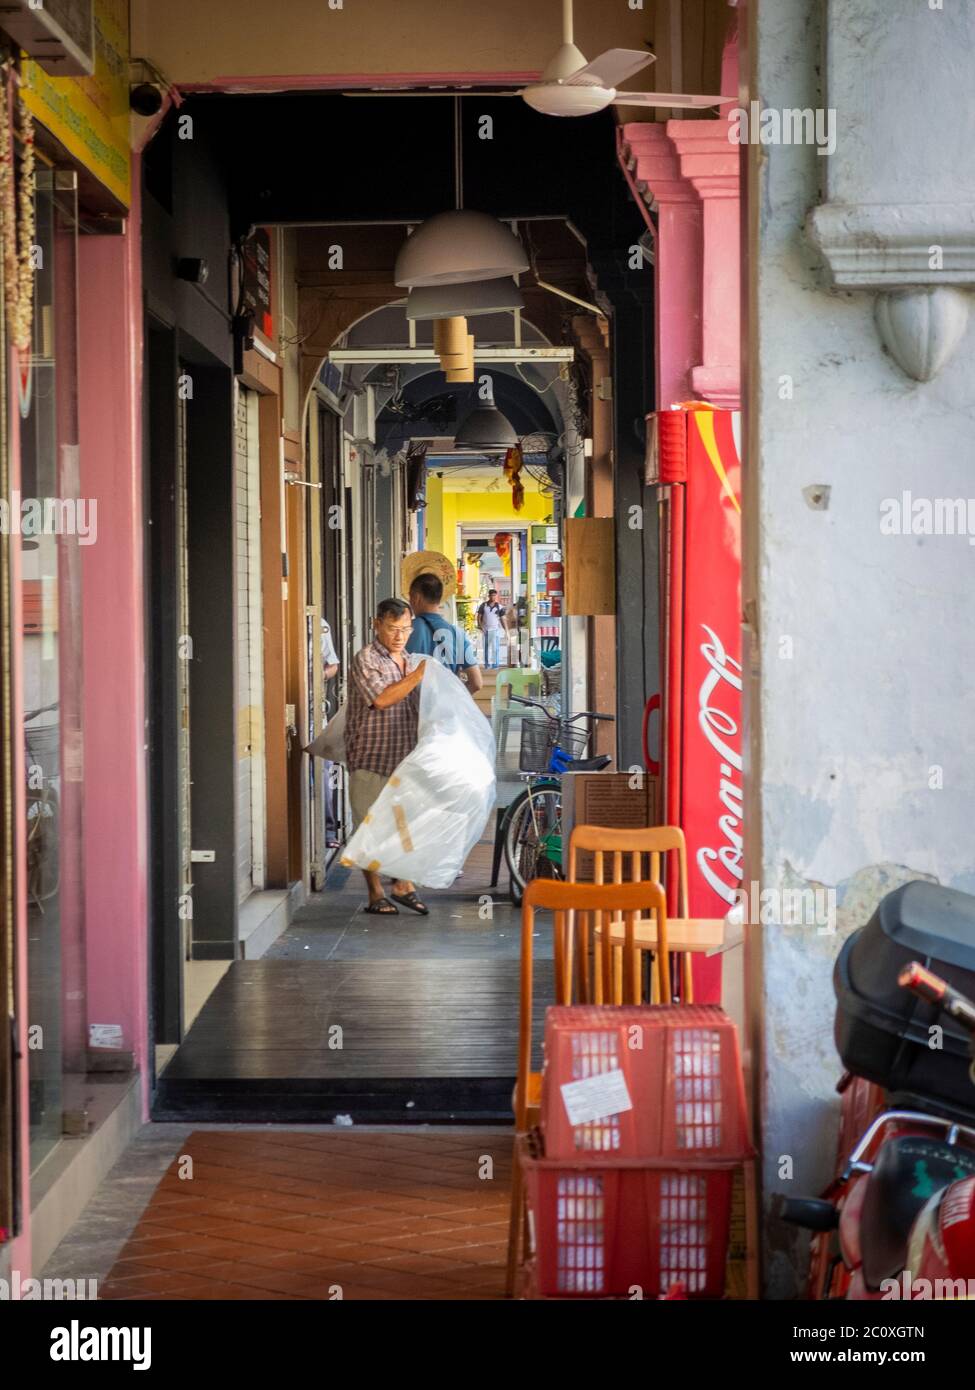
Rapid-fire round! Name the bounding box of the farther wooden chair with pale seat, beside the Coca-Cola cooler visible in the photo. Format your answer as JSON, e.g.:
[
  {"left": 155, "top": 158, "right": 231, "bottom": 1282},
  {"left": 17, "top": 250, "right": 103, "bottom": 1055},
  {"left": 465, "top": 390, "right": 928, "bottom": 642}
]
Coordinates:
[{"left": 569, "top": 826, "right": 725, "bottom": 1004}]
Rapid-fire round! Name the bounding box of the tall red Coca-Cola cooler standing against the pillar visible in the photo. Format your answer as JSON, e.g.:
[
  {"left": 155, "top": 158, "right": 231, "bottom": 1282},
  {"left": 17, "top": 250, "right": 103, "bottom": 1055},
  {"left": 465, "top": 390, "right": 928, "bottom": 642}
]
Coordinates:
[{"left": 644, "top": 402, "right": 743, "bottom": 1004}]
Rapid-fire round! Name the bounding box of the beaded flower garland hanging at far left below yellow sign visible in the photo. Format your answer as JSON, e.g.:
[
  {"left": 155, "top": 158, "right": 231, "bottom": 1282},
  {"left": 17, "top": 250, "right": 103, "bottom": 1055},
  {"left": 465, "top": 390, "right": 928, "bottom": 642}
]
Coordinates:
[{"left": 0, "top": 67, "right": 36, "bottom": 355}]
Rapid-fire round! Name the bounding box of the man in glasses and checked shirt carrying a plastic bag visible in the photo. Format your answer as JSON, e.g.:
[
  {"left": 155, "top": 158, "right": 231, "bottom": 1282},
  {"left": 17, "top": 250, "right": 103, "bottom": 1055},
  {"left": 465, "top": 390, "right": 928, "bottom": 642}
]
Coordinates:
[{"left": 345, "top": 599, "right": 428, "bottom": 916}]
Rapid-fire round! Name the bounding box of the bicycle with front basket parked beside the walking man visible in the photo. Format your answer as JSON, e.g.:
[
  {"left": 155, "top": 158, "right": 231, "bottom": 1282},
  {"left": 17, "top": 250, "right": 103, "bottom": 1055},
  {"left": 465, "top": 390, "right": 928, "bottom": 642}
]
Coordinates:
[{"left": 503, "top": 695, "right": 615, "bottom": 906}]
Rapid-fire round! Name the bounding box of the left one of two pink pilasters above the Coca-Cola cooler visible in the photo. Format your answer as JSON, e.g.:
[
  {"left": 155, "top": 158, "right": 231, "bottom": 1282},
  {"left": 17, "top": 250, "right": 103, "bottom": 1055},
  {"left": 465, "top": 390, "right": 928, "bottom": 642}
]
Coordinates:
[{"left": 614, "top": 121, "right": 704, "bottom": 409}]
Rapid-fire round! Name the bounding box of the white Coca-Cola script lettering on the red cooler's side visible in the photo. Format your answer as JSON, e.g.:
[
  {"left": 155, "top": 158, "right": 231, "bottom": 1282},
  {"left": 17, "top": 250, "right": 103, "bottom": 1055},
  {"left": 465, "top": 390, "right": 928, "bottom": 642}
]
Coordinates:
[{"left": 695, "top": 623, "right": 744, "bottom": 904}]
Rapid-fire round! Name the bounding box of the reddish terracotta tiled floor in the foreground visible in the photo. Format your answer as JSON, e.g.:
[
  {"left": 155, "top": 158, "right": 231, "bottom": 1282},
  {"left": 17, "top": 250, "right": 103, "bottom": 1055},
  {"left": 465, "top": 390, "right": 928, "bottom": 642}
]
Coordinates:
[{"left": 103, "top": 1129, "right": 510, "bottom": 1301}]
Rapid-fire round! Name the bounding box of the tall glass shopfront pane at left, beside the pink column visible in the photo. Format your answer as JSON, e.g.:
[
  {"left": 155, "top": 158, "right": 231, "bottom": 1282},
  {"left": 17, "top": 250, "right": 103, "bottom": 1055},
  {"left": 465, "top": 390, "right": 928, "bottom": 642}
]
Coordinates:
[{"left": 19, "top": 168, "right": 87, "bottom": 1169}]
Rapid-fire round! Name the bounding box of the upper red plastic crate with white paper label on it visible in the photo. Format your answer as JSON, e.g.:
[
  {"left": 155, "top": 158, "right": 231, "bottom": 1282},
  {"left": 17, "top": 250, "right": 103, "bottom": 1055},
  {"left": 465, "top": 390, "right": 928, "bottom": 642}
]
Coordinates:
[{"left": 540, "top": 1004, "right": 752, "bottom": 1163}]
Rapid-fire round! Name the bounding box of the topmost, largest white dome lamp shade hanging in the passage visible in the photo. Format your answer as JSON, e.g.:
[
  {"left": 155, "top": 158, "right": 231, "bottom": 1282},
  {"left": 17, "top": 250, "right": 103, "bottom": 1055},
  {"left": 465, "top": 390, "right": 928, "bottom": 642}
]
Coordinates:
[{"left": 394, "top": 209, "right": 529, "bottom": 289}]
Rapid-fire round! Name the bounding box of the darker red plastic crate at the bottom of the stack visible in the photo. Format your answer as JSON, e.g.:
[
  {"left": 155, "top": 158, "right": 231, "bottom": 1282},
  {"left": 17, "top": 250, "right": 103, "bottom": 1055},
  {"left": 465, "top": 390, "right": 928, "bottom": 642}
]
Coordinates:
[{"left": 519, "top": 1136, "right": 737, "bottom": 1298}]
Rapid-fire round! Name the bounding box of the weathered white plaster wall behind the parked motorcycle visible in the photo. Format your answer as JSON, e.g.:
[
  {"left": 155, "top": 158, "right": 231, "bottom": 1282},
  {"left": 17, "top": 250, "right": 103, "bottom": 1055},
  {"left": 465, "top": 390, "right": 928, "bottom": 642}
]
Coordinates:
[{"left": 746, "top": 0, "right": 975, "bottom": 1295}]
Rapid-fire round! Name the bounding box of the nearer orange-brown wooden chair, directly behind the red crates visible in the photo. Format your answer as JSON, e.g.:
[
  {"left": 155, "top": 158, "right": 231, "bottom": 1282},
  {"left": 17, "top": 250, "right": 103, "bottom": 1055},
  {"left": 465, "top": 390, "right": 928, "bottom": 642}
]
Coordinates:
[{"left": 506, "top": 878, "right": 669, "bottom": 1298}]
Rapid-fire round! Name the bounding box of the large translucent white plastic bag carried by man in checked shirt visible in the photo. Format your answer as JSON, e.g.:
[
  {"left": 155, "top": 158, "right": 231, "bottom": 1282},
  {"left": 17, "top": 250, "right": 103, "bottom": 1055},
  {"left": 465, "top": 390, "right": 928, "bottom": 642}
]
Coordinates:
[{"left": 342, "top": 657, "right": 495, "bottom": 888}]
